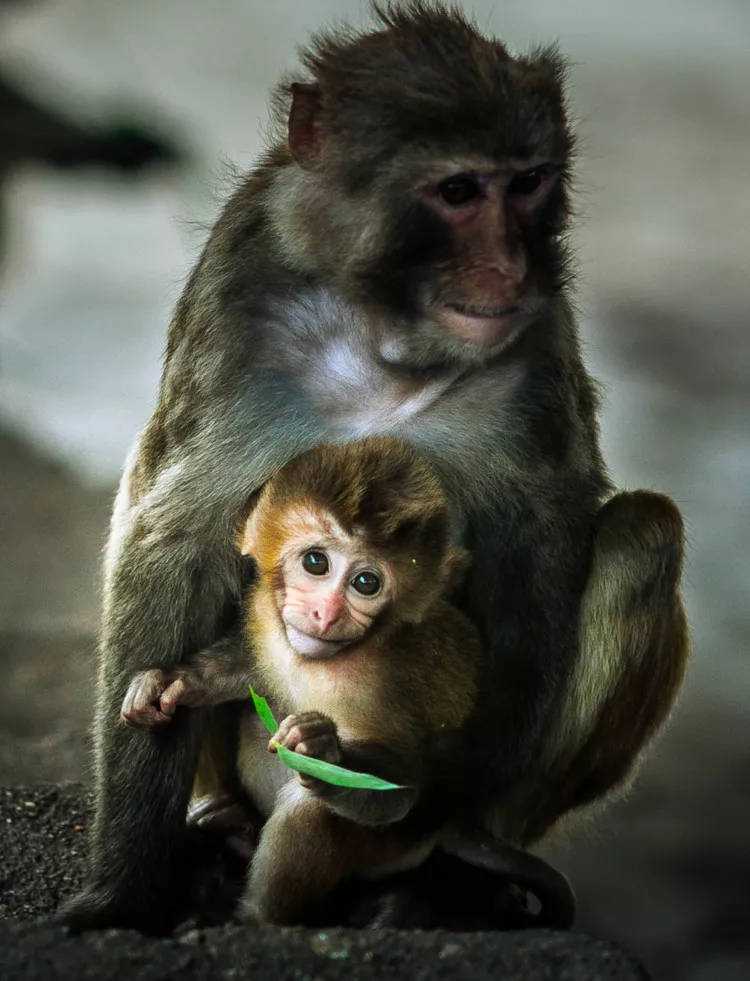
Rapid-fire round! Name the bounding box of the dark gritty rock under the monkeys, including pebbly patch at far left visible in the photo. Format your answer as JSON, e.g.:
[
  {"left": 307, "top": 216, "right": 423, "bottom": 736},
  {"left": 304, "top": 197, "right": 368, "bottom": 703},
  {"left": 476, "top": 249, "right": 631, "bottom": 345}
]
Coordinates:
[{"left": 0, "top": 784, "right": 647, "bottom": 981}]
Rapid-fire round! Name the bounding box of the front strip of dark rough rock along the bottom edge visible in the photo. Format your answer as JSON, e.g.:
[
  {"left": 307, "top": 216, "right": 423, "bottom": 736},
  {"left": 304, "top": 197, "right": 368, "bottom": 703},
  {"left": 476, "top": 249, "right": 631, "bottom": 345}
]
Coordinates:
[{"left": 0, "top": 924, "right": 646, "bottom": 981}]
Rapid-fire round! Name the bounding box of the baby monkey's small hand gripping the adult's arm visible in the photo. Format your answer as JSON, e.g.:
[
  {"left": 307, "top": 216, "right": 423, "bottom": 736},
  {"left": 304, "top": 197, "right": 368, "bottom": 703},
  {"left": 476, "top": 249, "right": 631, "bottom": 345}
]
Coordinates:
[{"left": 120, "top": 668, "right": 207, "bottom": 729}]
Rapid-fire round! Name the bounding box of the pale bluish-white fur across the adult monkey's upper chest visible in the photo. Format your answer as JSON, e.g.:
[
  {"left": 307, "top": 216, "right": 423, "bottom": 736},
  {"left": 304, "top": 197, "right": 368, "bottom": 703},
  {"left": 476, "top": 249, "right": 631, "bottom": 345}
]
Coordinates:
[{"left": 263, "top": 293, "right": 524, "bottom": 503}]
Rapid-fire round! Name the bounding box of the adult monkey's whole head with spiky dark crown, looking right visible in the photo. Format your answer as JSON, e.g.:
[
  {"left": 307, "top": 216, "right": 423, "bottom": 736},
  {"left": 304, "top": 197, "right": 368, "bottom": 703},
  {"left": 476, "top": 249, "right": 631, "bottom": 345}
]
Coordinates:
[{"left": 277, "top": 0, "right": 573, "bottom": 366}]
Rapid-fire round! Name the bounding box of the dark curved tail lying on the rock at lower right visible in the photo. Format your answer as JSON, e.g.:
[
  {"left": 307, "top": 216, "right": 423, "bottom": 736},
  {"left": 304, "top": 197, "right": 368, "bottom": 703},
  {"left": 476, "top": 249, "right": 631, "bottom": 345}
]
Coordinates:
[{"left": 438, "top": 825, "right": 576, "bottom": 930}]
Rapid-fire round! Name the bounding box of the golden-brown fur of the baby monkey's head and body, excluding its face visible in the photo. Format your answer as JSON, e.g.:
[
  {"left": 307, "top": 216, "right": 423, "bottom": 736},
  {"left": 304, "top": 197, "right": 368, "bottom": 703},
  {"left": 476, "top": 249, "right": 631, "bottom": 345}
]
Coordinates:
[{"left": 193, "top": 438, "right": 481, "bottom": 923}]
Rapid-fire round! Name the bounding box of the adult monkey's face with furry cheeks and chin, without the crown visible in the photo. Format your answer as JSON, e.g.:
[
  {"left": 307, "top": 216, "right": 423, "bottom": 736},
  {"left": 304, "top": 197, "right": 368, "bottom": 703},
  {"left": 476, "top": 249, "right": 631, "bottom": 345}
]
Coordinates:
[{"left": 304, "top": 147, "right": 566, "bottom": 367}]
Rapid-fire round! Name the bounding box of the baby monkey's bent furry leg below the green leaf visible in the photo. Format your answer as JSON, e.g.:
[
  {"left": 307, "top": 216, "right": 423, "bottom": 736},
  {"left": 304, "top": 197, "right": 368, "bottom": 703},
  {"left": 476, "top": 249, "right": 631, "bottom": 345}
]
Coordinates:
[{"left": 240, "top": 782, "right": 432, "bottom": 925}]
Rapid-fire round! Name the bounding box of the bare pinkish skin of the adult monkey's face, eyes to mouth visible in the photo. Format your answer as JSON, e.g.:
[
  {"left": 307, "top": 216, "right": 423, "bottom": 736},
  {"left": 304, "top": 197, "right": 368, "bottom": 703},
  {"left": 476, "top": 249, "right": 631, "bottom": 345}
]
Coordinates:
[{"left": 417, "top": 162, "right": 560, "bottom": 347}]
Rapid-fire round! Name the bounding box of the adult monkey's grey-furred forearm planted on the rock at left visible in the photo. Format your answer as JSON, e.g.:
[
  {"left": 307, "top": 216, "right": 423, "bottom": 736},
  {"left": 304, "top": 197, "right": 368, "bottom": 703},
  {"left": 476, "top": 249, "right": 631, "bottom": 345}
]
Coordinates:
[{"left": 60, "top": 504, "right": 241, "bottom": 934}]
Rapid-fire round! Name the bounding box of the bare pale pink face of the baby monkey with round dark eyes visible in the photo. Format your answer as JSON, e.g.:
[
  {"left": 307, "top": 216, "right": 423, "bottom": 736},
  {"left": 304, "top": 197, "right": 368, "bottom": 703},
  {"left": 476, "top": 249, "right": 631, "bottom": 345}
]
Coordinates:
[{"left": 279, "top": 535, "right": 393, "bottom": 658}]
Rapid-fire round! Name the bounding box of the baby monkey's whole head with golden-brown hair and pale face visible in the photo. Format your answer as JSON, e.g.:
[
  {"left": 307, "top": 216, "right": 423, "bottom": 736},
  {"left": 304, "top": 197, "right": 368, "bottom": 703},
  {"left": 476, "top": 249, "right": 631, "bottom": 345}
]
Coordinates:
[{"left": 242, "top": 438, "right": 468, "bottom": 658}]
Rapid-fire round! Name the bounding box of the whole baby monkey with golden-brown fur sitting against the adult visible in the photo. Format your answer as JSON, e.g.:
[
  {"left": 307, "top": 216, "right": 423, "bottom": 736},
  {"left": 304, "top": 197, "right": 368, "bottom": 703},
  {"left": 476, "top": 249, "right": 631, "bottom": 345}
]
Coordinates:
[{"left": 122, "top": 438, "right": 482, "bottom": 924}]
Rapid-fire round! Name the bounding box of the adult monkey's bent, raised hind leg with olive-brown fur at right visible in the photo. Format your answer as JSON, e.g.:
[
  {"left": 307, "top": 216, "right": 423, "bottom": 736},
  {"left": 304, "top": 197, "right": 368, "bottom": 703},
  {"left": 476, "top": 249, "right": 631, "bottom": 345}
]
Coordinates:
[{"left": 512, "top": 491, "right": 689, "bottom": 844}]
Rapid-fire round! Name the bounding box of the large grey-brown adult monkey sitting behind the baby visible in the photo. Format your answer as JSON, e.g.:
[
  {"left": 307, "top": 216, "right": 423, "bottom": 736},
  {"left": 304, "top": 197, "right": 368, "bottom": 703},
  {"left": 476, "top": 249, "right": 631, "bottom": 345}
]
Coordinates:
[{"left": 65, "top": 2, "right": 686, "bottom": 932}]
